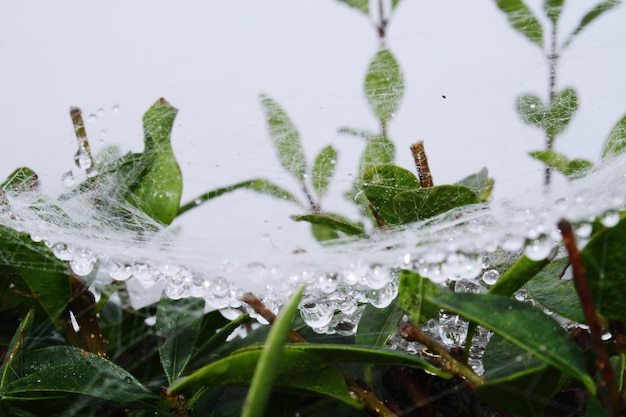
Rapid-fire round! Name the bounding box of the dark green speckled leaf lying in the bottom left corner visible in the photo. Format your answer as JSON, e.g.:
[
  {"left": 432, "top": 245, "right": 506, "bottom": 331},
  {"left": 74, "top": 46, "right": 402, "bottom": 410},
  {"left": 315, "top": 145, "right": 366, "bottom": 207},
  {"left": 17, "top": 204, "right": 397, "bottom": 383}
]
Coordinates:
[{"left": 0, "top": 346, "right": 161, "bottom": 404}]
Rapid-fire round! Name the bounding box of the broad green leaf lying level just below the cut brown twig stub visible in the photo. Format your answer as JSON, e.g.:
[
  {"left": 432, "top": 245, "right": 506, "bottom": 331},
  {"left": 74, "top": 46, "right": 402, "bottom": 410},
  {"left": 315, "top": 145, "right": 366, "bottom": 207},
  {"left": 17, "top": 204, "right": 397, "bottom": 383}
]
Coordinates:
[{"left": 393, "top": 185, "right": 480, "bottom": 224}]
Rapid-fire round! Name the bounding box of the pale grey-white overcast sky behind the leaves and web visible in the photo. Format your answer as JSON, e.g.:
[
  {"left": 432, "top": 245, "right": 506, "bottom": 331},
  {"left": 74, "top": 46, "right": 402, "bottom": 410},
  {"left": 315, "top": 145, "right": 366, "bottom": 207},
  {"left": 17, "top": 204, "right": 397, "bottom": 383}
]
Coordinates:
[{"left": 0, "top": 0, "right": 626, "bottom": 256}]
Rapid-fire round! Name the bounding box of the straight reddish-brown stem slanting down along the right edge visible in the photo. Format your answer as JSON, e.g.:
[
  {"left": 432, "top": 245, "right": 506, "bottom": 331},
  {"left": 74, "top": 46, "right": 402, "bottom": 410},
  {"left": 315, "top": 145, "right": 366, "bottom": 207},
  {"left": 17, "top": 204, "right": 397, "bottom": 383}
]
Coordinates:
[{"left": 558, "top": 219, "right": 624, "bottom": 416}]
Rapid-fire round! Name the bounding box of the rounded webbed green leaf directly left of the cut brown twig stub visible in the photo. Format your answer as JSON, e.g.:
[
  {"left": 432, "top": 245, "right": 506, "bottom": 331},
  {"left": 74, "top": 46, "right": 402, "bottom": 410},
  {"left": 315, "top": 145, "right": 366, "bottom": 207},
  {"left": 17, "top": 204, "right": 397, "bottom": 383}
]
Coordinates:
[{"left": 362, "top": 164, "right": 420, "bottom": 225}]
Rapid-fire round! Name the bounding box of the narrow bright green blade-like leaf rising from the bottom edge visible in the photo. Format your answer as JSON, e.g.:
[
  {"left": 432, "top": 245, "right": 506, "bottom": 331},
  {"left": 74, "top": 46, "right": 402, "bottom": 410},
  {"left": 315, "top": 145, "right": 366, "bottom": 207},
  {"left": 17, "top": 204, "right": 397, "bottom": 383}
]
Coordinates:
[{"left": 241, "top": 285, "right": 305, "bottom": 417}]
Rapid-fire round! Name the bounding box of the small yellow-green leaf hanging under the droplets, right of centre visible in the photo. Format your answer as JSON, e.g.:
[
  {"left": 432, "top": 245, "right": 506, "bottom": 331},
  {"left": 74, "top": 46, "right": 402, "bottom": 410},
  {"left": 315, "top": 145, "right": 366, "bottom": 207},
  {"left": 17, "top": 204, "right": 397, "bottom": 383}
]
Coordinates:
[{"left": 398, "top": 269, "right": 441, "bottom": 326}]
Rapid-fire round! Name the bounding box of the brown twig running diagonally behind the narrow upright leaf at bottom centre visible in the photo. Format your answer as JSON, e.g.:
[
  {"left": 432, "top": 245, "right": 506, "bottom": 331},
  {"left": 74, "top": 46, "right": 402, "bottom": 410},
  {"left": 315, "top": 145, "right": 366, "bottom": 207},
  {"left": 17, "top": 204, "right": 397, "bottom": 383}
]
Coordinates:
[{"left": 241, "top": 292, "right": 396, "bottom": 417}]
